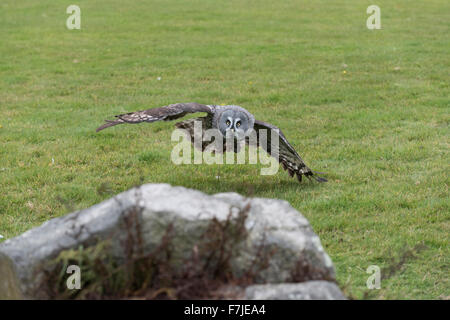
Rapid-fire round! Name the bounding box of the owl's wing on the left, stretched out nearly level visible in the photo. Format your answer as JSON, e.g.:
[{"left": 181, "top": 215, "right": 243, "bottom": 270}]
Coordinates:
[{"left": 96, "top": 102, "right": 214, "bottom": 132}]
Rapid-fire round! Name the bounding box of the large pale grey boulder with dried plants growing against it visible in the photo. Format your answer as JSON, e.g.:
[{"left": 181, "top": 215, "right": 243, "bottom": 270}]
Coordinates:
[{"left": 0, "top": 184, "right": 335, "bottom": 299}]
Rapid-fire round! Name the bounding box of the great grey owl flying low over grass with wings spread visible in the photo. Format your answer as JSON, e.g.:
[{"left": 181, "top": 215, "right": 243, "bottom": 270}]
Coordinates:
[{"left": 96, "top": 102, "right": 327, "bottom": 182}]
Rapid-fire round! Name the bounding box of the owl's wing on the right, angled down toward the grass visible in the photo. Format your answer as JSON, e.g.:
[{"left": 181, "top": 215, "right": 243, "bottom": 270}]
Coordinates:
[{"left": 247, "top": 120, "right": 327, "bottom": 182}]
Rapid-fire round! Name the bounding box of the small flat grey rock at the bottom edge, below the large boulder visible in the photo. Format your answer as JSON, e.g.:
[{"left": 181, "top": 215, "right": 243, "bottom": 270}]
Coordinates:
[{"left": 245, "top": 281, "right": 346, "bottom": 300}]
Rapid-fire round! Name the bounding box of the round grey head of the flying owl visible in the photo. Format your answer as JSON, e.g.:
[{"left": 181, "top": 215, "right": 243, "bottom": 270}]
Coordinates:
[{"left": 216, "top": 106, "right": 255, "bottom": 140}]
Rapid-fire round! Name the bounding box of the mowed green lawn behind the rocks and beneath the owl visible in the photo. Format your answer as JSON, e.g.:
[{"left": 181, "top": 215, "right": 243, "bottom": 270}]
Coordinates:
[{"left": 0, "top": 0, "right": 450, "bottom": 299}]
